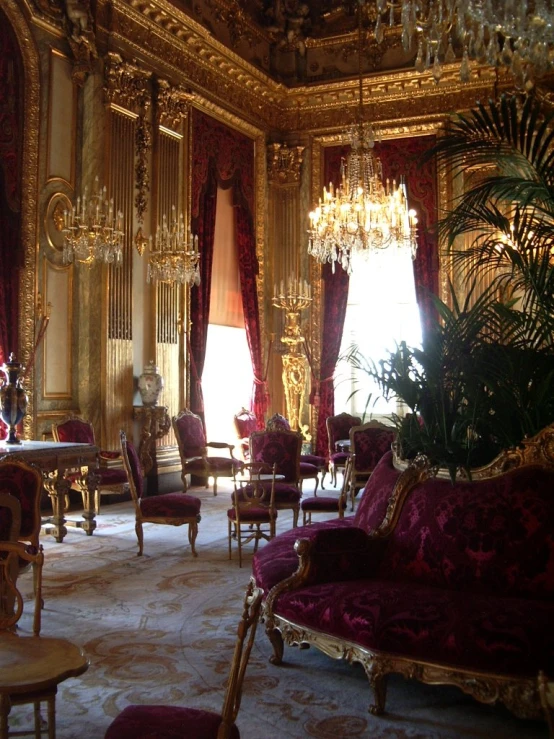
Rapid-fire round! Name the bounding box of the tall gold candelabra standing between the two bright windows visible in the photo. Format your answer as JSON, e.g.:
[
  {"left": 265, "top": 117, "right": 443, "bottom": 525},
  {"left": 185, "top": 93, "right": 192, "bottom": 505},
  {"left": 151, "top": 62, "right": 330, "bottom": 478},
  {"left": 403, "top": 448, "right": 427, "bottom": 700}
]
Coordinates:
[{"left": 272, "top": 275, "right": 312, "bottom": 431}]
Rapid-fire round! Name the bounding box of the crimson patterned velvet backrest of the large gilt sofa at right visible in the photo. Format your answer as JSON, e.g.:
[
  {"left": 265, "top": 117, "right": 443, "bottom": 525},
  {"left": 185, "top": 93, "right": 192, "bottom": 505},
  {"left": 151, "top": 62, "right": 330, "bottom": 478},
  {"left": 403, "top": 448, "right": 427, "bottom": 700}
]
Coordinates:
[{"left": 378, "top": 467, "right": 554, "bottom": 599}]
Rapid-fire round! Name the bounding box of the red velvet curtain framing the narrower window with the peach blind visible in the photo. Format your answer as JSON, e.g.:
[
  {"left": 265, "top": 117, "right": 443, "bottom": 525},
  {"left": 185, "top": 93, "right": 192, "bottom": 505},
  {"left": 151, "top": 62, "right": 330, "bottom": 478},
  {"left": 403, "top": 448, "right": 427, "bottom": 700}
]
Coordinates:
[{"left": 190, "top": 110, "right": 267, "bottom": 428}]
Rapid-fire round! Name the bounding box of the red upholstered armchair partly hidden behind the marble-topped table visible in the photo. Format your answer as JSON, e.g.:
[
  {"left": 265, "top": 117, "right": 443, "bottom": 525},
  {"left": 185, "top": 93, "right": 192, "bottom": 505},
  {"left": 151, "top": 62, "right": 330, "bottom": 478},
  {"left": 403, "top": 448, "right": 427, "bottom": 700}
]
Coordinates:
[{"left": 52, "top": 415, "right": 129, "bottom": 515}]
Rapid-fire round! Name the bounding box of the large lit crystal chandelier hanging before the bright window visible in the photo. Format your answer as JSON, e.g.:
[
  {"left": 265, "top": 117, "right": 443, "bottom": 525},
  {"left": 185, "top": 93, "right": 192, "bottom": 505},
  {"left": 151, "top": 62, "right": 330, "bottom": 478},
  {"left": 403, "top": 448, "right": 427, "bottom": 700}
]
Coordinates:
[{"left": 308, "top": 5, "right": 417, "bottom": 274}]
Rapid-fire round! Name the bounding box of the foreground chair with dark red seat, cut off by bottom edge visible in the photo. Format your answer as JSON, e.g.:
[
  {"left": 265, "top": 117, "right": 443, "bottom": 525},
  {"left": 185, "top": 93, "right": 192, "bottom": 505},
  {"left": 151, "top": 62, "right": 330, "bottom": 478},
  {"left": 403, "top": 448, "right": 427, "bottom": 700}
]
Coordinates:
[{"left": 104, "top": 581, "right": 262, "bottom": 739}]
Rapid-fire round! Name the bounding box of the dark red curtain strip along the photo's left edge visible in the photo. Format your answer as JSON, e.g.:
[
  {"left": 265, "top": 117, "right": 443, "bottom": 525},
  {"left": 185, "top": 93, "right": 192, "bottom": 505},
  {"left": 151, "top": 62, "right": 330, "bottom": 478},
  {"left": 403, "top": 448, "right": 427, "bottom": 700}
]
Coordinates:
[{"left": 0, "top": 9, "right": 23, "bottom": 363}]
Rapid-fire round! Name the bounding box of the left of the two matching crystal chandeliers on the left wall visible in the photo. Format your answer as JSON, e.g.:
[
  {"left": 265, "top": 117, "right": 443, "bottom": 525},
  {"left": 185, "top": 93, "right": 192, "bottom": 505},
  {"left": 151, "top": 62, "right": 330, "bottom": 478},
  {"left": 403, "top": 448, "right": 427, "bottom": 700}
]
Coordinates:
[{"left": 62, "top": 177, "right": 124, "bottom": 265}]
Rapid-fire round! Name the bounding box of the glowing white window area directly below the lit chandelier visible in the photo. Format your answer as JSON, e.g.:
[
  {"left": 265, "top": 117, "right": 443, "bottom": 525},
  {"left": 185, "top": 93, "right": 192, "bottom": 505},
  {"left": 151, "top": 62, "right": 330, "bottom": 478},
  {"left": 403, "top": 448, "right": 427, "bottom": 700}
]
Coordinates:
[{"left": 335, "top": 247, "right": 421, "bottom": 421}]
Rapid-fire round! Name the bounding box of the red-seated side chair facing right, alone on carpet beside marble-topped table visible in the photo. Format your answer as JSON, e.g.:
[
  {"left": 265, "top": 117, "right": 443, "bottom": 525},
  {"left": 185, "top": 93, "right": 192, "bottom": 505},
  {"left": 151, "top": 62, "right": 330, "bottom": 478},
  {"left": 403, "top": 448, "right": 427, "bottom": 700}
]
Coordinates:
[{"left": 120, "top": 431, "right": 201, "bottom": 557}]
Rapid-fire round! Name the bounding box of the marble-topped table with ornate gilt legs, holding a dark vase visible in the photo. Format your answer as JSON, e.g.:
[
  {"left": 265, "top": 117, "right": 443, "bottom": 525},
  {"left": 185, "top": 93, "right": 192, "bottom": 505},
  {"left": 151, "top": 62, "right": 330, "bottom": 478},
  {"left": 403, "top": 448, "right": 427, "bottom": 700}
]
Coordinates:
[{"left": 0, "top": 441, "right": 98, "bottom": 542}]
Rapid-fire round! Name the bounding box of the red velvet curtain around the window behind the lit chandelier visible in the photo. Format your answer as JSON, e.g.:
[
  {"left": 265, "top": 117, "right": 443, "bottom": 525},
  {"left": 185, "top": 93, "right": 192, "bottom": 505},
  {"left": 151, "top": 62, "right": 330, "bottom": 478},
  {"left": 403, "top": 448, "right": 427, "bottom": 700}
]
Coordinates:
[{"left": 311, "top": 136, "right": 439, "bottom": 455}]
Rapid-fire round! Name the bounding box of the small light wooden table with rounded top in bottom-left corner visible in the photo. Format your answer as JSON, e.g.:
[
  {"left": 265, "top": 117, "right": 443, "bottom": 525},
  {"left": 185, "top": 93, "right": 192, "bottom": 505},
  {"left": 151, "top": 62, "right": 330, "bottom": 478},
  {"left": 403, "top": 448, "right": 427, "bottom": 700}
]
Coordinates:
[{"left": 0, "top": 632, "right": 89, "bottom": 739}]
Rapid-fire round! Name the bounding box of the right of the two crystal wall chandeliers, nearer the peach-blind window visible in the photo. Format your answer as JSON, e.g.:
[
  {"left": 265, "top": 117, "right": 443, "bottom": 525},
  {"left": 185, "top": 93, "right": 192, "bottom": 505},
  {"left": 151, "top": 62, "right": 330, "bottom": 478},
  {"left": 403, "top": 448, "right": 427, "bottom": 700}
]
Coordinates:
[{"left": 146, "top": 206, "right": 200, "bottom": 285}]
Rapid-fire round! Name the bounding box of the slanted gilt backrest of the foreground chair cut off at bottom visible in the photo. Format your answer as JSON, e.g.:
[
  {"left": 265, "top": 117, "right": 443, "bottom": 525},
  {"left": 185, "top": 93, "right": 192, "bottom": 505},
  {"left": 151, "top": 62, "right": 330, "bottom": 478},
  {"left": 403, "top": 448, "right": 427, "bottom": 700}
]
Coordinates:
[{"left": 217, "top": 580, "right": 262, "bottom": 739}]
